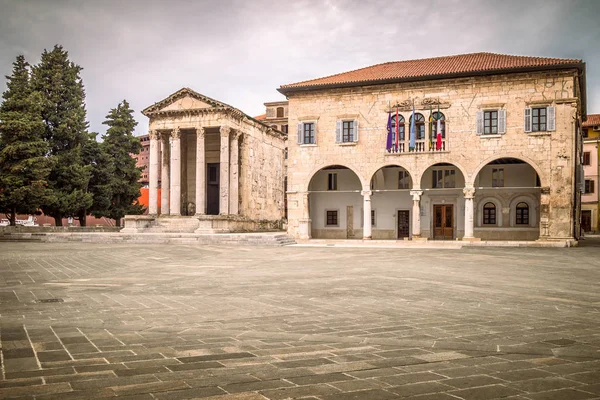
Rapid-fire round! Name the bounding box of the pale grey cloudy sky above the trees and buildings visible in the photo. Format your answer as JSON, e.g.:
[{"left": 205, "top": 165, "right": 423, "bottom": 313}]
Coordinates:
[{"left": 0, "top": 0, "right": 600, "bottom": 134}]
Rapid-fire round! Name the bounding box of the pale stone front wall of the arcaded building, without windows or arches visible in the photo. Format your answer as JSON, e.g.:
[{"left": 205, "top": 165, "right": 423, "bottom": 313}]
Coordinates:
[{"left": 288, "top": 70, "right": 580, "bottom": 238}]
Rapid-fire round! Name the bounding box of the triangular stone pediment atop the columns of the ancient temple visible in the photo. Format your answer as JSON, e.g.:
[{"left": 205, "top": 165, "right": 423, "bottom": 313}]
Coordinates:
[{"left": 142, "top": 88, "right": 234, "bottom": 116}]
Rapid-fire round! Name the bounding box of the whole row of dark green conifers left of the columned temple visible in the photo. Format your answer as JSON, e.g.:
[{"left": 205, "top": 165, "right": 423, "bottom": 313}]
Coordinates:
[{"left": 0, "top": 45, "right": 144, "bottom": 226}]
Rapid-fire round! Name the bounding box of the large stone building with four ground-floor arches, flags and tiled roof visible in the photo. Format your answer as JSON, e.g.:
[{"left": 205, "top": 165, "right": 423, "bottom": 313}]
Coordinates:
[{"left": 278, "top": 53, "right": 586, "bottom": 243}]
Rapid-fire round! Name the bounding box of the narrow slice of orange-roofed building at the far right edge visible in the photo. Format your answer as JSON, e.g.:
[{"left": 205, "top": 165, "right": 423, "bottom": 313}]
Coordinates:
[{"left": 581, "top": 114, "right": 600, "bottom": 232}]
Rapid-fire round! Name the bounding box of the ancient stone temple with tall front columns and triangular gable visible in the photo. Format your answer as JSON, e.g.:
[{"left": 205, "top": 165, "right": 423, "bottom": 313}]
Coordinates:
[{"left": 123, "top": 88, "right": 286, "bottom": 232}]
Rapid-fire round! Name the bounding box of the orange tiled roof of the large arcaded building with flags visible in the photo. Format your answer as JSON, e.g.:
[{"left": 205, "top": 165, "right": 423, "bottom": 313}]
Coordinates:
[{"left": 278, "top": 53, "right": 582, "bottom": 94}]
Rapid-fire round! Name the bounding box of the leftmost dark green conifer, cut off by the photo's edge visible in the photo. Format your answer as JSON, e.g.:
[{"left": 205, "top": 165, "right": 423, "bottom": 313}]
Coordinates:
[{"left": 0, "top": 55, "right": 50, "bottom": 226}]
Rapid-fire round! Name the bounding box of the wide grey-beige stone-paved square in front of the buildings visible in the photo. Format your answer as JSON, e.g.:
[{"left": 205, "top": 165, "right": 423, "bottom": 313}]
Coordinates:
[{"left": 0, "top": 243, "right": 600, "bottom": 400}]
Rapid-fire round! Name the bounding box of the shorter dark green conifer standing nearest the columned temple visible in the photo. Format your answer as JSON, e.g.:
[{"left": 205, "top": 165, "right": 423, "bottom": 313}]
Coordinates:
[{"left": 102, "top": 100, "right": 144, "bottom": 226}]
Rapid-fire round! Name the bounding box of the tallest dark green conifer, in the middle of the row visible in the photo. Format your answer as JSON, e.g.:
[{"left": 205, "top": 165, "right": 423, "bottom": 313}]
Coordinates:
[{"left": 32, "top": 45, "right": 92, "bottom": 226}]
